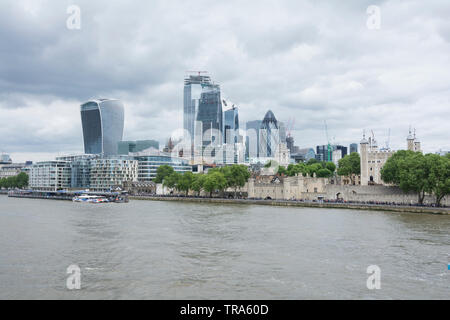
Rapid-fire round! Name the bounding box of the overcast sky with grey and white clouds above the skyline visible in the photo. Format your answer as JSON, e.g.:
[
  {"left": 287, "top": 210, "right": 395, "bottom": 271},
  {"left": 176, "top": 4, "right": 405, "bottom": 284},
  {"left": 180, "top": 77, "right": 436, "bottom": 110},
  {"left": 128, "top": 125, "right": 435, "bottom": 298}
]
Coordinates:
[{"left": 0, "top": 0, "right": 450, "bottom": 161}]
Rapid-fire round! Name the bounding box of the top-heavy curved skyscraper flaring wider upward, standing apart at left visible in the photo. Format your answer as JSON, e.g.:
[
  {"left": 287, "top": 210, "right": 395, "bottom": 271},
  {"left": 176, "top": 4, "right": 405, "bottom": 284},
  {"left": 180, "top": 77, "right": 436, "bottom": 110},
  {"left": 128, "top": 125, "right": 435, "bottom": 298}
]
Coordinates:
[{"left": 80, "top": 99, "right": 124, "bottom": 156}]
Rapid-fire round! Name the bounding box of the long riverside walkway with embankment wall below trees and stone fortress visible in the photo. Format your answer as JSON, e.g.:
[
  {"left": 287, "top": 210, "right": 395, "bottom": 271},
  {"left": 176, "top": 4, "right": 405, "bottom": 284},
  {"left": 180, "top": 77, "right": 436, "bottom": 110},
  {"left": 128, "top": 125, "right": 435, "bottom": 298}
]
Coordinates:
[{"left": 130, "top": 196, "right": 450, "bottom": 215}]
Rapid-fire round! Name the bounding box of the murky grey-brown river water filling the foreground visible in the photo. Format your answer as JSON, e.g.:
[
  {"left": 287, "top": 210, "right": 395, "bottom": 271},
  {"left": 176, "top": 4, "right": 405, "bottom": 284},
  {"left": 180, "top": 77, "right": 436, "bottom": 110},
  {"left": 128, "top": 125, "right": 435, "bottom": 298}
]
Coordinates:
[{"left": 0, "top": 196, "right": 450, "bottom": 299}]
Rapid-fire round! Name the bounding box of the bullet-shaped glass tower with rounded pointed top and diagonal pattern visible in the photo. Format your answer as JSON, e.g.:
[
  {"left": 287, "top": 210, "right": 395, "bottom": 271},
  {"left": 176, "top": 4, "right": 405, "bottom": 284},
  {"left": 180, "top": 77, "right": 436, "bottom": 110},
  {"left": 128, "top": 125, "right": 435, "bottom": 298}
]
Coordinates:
[{"left": 259, "top": 110, "right": 281, "bottom": 157}]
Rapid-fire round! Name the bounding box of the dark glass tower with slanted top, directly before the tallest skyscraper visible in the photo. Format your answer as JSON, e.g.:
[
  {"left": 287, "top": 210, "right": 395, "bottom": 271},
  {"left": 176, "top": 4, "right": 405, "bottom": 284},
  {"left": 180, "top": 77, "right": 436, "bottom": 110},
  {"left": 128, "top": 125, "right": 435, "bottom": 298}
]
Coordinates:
[{"left": 195, "top": 84, "right": 223, "bottom": 156}]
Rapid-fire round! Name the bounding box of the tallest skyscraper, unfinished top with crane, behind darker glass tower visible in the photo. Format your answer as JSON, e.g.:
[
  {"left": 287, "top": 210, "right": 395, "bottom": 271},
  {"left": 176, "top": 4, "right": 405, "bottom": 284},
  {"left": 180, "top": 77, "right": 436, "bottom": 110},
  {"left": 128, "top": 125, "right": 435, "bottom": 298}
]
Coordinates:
[{"left": 183, "top": 75, "right": 213, "bottom": 144}]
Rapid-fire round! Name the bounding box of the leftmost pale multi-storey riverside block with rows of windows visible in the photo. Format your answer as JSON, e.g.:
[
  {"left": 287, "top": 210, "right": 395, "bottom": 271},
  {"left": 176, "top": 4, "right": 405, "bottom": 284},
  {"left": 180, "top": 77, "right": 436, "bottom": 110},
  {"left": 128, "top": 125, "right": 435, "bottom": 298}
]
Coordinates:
[{"left": 29, "top": 160, "right": 71, "bottom": 191}]
